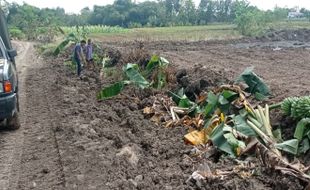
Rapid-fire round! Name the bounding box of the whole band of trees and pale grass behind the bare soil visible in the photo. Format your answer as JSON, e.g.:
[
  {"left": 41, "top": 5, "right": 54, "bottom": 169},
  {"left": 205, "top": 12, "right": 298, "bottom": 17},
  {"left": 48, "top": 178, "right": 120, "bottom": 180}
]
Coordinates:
[{"left": 1, "top": 0, "right": 310, "bottom": 42}]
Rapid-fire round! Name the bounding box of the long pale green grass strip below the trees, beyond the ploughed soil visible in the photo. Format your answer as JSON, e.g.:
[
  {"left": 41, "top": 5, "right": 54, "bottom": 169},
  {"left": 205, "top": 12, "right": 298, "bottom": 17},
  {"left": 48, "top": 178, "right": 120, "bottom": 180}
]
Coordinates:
[{"left": 90, "top": 24, "right": 241, "bottom": 41}]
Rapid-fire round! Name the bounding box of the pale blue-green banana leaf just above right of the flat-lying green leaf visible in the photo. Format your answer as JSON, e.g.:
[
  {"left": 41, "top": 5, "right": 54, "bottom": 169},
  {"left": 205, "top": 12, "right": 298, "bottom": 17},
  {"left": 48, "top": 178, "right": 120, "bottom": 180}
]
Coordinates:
[{"left": 123, "top": 63, "right": 150, "bottom": 89}]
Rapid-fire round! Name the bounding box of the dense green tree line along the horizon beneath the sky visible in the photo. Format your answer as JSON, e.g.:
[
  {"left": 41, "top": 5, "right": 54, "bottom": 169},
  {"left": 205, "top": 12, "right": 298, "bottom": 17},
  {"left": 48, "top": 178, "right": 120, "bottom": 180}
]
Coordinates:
[{"left": 3, "top": 0, "right": 309, "bottom": 38}]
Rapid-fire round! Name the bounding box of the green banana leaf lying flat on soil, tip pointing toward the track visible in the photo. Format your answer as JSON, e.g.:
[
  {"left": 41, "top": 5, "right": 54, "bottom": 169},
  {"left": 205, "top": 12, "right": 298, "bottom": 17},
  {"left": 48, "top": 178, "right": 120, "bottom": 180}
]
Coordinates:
[{"left": 97, "top": 81, "right": 128, "bottom": 100}]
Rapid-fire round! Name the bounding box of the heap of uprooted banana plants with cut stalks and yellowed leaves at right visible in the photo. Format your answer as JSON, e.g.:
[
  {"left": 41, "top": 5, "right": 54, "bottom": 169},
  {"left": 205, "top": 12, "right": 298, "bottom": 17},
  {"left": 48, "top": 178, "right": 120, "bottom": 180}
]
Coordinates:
[{"left": 144, "top": 70, "right": 310, "bottom": 181}]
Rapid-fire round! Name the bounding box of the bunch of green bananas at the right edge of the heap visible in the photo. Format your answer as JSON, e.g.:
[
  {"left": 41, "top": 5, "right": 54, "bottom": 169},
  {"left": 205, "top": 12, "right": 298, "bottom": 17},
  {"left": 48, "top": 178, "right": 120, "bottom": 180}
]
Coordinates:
[{"left": 281, "top": 96, "right": 310, "bottom": 120}]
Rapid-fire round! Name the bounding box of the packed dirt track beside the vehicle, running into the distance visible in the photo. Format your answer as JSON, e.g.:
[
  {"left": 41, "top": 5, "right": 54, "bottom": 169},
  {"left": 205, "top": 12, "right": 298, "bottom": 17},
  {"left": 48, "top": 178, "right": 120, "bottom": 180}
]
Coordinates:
[{"left": 0, "top": 42, "right": 65, "bottom": 189}]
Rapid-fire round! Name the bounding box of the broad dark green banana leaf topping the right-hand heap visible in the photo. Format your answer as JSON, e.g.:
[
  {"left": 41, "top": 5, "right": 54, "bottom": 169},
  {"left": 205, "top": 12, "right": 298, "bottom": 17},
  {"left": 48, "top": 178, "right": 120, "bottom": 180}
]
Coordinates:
[{"left": 236, "top": 67, "right": 271, "bottom": 98}]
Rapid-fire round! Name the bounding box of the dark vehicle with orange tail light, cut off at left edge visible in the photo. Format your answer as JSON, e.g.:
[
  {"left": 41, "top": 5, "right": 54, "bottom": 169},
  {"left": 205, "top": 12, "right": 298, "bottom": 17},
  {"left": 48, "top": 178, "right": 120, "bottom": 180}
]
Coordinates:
[{"left": 0, "top": 9, "right": 20, "bottom": 129}]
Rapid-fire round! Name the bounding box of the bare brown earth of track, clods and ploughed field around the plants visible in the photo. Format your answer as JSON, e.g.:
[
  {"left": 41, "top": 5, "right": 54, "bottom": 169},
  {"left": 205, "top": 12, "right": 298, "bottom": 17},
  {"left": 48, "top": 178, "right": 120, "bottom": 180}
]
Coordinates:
[{"left": 0, "top": 37, "right": 310, "bottom": 190}]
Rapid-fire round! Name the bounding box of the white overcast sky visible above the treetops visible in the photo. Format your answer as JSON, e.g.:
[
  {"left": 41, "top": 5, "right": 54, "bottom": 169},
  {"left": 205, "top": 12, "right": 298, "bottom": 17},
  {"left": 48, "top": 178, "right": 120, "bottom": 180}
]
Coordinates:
[{"left": 7, "top": 0, "right": 310, "bottom": 13}]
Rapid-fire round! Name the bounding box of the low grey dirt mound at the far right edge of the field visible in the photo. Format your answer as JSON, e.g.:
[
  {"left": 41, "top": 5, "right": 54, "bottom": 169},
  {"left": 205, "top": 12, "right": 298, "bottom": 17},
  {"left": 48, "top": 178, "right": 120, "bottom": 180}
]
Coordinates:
[{"left": 257, "top": 29, "right": 310, "bottom": 42}]
